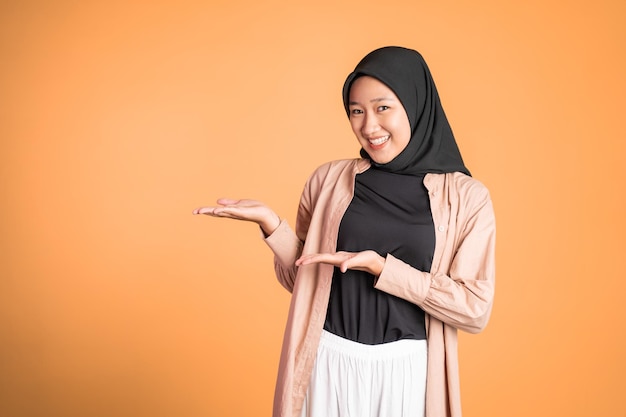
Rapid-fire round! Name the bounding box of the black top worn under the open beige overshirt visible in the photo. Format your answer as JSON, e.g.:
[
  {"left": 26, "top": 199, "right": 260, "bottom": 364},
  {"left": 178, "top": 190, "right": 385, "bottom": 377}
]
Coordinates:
[{"left": 324, "top": 168, "right": 435, "bottom": 344}]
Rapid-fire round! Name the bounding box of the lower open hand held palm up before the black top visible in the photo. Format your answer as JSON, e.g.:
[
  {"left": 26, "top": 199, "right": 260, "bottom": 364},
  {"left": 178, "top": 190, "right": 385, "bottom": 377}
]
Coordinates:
[{"left": 296, "top": 250, "right": 385, "bottom": 277}]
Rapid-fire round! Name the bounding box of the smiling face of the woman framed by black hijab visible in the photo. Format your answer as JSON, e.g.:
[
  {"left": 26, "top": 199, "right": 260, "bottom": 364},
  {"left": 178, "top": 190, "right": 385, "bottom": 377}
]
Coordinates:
[{"left": 348, "top": 76, "right": 411, "bottom": 164}]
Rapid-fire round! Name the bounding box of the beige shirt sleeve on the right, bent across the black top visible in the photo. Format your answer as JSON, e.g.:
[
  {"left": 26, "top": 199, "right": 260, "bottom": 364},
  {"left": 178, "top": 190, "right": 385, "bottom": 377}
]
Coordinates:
[{"left": 375, "top": 180, "right": 495, "bottom": 333}]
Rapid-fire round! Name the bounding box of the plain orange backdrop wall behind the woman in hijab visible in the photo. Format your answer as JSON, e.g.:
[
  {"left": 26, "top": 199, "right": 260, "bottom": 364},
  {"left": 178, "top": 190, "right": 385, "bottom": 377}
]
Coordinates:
[{"left": 0, "top": 0, "right": 626, "bottom": 417}]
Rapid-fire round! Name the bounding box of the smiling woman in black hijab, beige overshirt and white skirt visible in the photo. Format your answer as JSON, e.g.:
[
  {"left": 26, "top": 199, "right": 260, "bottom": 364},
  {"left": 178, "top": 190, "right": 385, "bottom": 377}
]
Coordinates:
[{"left": 194, "top": 47, "right": 495, "bottom": 417}]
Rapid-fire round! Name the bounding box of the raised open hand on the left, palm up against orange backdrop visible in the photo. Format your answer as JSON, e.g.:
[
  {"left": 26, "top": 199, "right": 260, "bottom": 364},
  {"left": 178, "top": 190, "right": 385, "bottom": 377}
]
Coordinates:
[{"left": 193, "top": 198, "right": 280, "bottom": 236}]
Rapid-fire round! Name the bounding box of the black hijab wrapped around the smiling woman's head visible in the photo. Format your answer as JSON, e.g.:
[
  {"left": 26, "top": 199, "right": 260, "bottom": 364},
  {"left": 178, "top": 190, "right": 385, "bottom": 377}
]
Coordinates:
[{"left": 343, "top": 46, "right": 470, "bottom": 175}]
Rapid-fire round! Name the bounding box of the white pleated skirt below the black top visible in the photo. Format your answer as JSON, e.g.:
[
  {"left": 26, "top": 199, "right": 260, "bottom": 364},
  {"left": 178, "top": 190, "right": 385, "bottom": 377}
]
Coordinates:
[{"left": 301, "top": 330, "right": 428, "bottom": 417}]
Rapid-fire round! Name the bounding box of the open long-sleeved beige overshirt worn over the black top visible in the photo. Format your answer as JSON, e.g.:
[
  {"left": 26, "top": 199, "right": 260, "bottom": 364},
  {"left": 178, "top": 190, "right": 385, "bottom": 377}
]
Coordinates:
[{"left": 266, "top": 159, "right": 495, "bottom": 417}]
